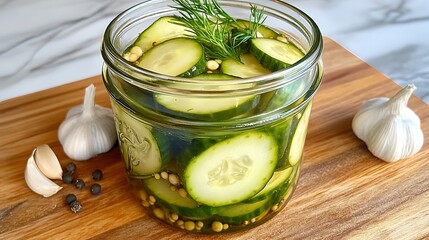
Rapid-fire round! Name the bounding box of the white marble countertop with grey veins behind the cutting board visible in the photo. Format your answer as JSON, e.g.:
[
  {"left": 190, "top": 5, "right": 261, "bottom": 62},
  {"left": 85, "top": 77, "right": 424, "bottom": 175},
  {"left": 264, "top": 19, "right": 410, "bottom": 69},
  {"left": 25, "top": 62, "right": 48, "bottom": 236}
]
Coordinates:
[{"left": 0, "top": 0, "right": 429, "bottom": 103}]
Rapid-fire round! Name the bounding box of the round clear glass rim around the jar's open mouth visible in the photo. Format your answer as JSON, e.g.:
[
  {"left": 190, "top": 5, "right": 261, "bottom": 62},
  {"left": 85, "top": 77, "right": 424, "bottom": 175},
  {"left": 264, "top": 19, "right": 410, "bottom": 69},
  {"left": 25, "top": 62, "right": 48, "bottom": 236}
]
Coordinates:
[{"left": 101, "top": 0, "right": 323, "bottom": 94}]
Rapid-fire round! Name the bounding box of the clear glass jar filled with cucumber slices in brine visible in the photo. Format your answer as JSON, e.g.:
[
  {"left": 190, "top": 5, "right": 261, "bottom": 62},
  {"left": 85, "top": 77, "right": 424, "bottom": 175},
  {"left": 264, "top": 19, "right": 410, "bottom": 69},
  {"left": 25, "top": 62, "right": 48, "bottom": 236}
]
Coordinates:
[{"left": 101, "top": 0, "right": 323, "bottom": 233}]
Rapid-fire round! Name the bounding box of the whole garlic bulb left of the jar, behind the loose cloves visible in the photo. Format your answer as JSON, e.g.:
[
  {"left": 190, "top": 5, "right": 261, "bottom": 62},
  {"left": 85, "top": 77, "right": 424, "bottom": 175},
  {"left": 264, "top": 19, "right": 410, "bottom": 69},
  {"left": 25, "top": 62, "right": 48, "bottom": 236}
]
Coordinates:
[{"left": 58, "top": 84, "right": 116, "bottom": 160}]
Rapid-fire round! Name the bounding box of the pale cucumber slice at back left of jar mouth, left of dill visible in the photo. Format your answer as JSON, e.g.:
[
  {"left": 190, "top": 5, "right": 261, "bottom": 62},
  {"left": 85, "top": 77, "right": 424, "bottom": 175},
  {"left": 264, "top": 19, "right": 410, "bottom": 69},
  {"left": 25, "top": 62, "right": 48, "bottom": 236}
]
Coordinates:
[{"left": 132, "top": 16, "right": 191, "bottom": 52}]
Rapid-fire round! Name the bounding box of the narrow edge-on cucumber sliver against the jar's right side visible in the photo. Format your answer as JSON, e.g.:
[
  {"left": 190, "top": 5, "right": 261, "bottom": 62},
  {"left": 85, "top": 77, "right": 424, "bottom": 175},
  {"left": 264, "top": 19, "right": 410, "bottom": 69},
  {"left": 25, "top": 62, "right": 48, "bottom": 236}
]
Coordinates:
[{"left": 288, "top": 102, "right": 312, "bottom": 166}]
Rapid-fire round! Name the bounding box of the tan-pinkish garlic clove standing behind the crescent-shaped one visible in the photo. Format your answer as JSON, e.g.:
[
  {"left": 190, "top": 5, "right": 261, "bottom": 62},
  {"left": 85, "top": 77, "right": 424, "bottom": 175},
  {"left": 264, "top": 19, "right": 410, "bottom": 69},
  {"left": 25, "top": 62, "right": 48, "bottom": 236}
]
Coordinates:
[{"left": 34, "top": 144, "right": 63, "bottom": 180}]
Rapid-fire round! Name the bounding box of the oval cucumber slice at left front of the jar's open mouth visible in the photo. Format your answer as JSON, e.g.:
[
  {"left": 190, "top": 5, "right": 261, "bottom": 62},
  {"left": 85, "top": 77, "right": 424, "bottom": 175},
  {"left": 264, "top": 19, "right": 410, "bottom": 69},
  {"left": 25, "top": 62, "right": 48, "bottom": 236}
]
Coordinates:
[{"left": 138, "top": 38, "right": 206, "bottom": 77}]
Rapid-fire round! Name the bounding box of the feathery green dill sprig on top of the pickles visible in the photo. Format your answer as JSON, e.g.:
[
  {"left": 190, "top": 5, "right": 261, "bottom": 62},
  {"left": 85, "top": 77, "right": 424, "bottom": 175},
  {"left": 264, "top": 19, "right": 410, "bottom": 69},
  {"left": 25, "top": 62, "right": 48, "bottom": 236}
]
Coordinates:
[{"left": 173, "top": 0, "right": 266, "bottom": 61}]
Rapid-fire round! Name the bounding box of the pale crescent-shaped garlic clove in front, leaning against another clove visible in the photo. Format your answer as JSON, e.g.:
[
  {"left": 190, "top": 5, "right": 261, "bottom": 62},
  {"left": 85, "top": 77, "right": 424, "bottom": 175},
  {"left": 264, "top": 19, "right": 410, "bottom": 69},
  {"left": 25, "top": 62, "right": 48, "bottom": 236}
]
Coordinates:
[{"left": 25, "top": 149, "right": 62, "bottom": 197}]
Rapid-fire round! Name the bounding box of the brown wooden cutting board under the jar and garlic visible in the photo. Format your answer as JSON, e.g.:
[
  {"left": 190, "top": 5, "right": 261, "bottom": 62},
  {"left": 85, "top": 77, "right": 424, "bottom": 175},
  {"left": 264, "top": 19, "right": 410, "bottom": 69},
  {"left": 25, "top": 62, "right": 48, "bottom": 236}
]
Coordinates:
[{"left": 0, "top": 39, "right": 429, "bottom": 239}]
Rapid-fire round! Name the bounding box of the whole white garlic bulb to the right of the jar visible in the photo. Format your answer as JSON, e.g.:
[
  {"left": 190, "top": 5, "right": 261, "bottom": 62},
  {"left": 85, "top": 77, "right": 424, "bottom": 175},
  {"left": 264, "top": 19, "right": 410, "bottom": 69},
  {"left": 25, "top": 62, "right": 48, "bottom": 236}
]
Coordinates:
[{"left": 352, "top": 84, "right": 423, "bottom": 162}]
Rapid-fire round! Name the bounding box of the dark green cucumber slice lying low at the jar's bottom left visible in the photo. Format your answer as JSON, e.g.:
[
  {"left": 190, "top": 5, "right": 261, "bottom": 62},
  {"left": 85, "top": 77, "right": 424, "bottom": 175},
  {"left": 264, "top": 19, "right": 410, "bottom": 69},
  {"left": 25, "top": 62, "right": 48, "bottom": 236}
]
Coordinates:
[{"left": 142, "top": 178, "right": 215, "bottom": 218}]
